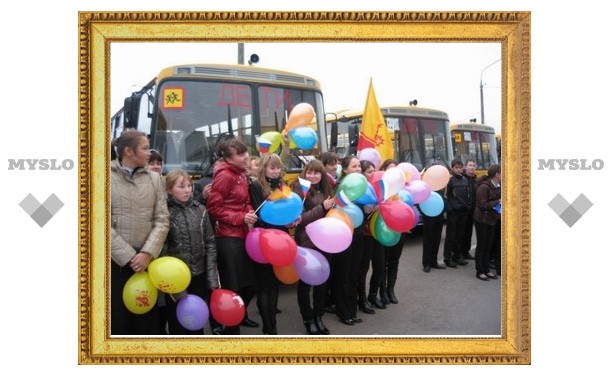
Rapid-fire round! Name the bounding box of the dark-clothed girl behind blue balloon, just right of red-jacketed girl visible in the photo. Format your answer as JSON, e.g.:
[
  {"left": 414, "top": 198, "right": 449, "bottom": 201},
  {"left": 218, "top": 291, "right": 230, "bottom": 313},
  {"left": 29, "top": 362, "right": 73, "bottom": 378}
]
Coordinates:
[{"left": 249, "top": 153, "right": 299, "bottom": 335}]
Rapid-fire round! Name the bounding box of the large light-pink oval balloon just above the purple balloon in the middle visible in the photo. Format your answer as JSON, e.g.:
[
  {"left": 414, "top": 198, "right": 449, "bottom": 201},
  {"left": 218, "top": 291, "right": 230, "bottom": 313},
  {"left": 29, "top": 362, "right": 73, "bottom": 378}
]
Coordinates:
[{"left": 306, "top": 217, "right": 353, "bottom": 253}]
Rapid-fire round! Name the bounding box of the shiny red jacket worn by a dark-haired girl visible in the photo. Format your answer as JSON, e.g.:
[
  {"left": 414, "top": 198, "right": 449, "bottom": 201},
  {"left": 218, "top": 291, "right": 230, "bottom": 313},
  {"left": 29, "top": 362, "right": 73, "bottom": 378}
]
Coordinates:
[{"left": 206, "top": 160, "right": 253, "bottom": 239}]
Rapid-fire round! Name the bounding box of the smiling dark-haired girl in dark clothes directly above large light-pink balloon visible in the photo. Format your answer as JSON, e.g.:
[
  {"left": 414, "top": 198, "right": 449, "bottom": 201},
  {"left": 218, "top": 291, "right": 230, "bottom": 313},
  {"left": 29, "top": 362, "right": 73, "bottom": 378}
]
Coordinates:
[{"left": 293, "top": 160, "right": 334, "bottom": 335}]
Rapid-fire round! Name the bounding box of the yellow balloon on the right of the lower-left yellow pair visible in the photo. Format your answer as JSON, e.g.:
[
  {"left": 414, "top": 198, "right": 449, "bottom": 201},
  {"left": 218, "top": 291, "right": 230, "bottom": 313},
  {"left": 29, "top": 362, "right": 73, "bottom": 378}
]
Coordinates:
[{"left": 148, "top": 256, "right": 191, "bottom": 294}]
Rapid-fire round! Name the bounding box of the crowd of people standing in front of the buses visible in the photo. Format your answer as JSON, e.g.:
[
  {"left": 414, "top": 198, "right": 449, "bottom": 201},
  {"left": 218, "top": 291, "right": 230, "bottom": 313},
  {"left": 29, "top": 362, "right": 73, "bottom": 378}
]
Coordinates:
[{"left": 111, "top": 130, "right": 501, "bottom": 335}]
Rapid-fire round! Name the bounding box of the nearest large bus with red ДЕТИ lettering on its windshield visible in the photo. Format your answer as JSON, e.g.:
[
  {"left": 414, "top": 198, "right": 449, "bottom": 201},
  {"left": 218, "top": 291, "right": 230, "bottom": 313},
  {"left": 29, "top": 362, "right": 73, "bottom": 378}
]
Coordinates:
[{"left": 111, "top": 65, "right": 327, "bottom": 176}]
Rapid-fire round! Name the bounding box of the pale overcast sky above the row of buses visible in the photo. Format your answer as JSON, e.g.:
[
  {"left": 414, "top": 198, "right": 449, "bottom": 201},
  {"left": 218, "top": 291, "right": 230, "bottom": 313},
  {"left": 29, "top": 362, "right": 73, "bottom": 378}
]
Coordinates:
[{"left": 111, "top": 42, "right": 501, "bottom": 131}]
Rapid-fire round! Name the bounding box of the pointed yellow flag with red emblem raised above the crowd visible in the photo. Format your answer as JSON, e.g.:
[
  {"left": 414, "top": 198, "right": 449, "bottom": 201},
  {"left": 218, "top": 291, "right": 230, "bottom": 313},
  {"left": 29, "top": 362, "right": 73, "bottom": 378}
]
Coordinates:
[{"left": 357, "top": 79, "right": 394, "bottom": 162}]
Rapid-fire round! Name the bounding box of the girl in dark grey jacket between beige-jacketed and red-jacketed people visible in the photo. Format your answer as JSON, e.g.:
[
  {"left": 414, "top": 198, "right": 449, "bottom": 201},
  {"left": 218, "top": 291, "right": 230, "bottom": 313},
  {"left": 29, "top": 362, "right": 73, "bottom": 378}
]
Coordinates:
[{"left": 164, "top": 169, "right": 219, "bottom": 335}]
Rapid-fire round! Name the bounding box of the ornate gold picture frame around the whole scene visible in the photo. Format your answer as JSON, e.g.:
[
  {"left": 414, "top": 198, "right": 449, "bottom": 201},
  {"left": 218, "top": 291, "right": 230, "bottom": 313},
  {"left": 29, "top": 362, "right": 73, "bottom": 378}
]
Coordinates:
[{"left": 78, "top": 11, "right": 531, "bottom": 364}]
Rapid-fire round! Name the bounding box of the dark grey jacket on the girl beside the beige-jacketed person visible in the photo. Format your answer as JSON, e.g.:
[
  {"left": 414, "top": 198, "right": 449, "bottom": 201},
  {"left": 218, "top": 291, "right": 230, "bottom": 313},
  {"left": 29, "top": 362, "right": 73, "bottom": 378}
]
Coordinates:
[{"left": 163, "top": 196, "right": 219, "bottom": 287}]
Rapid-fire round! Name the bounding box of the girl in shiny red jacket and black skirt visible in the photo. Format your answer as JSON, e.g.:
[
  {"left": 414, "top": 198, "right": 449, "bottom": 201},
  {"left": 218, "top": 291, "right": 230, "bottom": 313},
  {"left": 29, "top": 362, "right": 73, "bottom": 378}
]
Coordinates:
[{"left": 207, "top": 139, "right": 257, "bottom": 335}]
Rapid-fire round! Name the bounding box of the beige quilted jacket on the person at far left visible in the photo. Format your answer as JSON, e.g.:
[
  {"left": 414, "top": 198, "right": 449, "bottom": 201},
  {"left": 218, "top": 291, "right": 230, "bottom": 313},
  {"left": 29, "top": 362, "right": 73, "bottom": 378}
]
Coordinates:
[{"left": 111, "top": 160, "right": 168, "bottom": 266}]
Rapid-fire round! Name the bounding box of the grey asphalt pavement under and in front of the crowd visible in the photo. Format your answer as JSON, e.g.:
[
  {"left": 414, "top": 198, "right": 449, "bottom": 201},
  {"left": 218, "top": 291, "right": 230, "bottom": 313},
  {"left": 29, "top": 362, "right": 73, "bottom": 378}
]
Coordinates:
[{"left": 234, "top": 226, "right": 503, "bottom": 337}]
